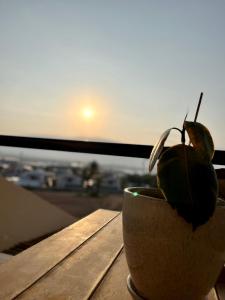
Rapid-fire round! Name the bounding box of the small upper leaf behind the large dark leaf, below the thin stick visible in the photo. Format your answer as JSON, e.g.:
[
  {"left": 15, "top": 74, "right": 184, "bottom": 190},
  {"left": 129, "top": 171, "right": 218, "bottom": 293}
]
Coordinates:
[{"left": 184, "top": 121, "right": 214, "bottom": 162}]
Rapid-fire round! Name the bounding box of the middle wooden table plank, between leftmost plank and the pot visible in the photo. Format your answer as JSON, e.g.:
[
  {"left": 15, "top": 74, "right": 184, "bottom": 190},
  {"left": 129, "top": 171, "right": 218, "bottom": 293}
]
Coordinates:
[{"left": 17, "top": 216, "right": 123, "bottom": 300}]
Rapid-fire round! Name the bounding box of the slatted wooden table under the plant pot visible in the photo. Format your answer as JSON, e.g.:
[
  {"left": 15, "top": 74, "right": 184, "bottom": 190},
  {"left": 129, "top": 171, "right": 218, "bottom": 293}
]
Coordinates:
[{"left": 0, "top": 210, "right": 225, "bottom": 300}]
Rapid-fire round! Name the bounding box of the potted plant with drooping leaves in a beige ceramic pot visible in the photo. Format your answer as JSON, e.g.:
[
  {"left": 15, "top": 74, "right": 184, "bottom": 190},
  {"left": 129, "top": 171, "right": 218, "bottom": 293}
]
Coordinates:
[{"left": 123, "top": 94, "right": 225, "bottom": 300}]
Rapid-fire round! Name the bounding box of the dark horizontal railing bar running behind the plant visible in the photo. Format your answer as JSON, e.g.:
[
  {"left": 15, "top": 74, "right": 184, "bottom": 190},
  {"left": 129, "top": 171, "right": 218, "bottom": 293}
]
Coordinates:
[{"left": 0, "top": 135, "right": 225, "bottom": 165}]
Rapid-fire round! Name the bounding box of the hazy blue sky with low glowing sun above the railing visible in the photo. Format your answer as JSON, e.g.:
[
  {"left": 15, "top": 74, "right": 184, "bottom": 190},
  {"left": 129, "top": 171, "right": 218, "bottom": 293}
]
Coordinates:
[{"left": 0, "top": 0, "right": 225, "bottom": 150}]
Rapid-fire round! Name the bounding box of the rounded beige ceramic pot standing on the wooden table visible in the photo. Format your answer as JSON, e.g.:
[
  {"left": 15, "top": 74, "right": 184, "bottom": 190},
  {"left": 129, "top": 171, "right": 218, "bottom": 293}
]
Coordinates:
[{"left": 123, "top": 188, "right": 225, "bottom": 300}]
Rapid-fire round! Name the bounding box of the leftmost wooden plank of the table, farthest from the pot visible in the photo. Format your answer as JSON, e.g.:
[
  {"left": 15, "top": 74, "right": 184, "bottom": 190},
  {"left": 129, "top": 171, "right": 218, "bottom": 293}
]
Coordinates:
[{"left": 0, "top": 210, "right": 119, "bottom": 300}]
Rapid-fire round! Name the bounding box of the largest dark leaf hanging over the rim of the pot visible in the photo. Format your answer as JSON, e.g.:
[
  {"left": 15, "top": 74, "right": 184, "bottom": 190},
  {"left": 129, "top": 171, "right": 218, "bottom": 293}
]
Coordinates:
[{"left": 158, "top": 144, "right": 218, "bottom": 229}]
